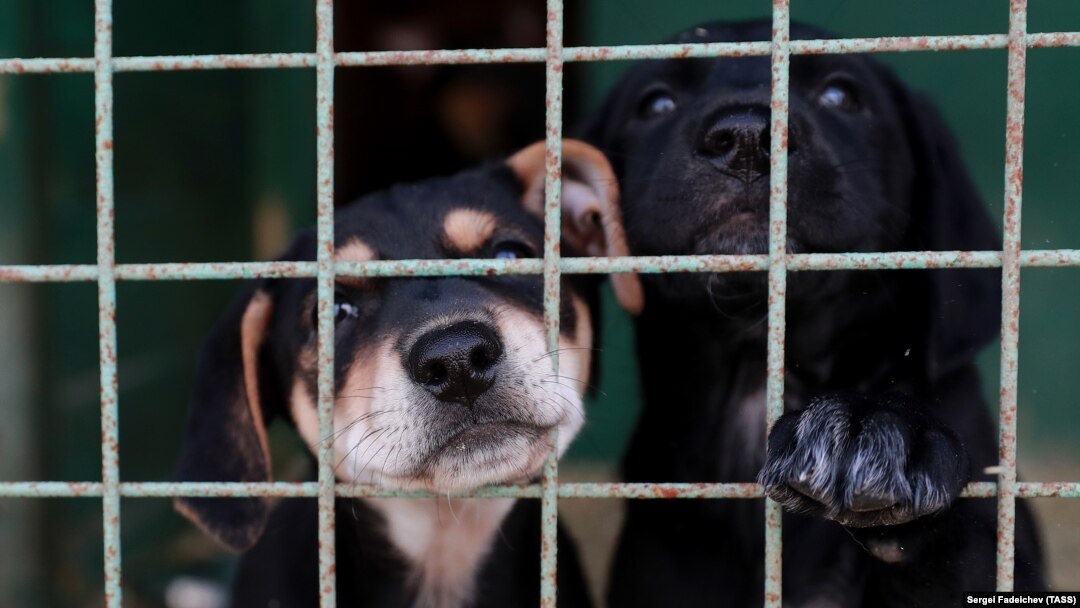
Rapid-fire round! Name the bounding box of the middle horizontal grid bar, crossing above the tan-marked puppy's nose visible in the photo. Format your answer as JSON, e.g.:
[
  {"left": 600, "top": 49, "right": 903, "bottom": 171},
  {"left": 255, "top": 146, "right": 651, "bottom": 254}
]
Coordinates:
[{"left": 0, "top": 249, "right": 1080, "bottom": 283}]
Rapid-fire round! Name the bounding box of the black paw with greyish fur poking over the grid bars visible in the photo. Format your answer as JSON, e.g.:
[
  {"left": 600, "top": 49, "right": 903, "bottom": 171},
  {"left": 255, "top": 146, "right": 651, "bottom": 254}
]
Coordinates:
[{"left": 758, "top": 395, "right": 969, "bottom": 528}]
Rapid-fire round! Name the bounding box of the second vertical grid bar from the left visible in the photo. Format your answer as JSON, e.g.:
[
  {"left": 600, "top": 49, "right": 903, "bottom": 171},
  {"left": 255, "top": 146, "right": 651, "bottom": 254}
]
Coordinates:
[{"left": 315, "top": 0, "right": 337, "bottom": 608}]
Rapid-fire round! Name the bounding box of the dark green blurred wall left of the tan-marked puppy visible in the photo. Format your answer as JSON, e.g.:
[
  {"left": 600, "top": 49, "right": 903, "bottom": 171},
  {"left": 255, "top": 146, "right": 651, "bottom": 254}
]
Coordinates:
[{"left": 0, "top": 0, "right": 315, "bottom": 607}]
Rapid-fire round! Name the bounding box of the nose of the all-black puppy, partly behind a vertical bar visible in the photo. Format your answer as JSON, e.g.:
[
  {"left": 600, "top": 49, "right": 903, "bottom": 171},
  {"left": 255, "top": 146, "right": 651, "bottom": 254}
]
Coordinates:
[{"left": 700, "top": 111, "right": 769, "bottom": 178}]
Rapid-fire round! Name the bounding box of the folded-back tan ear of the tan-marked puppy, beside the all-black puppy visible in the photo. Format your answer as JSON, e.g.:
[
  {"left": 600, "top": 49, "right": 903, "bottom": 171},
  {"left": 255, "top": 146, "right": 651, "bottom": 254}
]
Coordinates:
[{"left": 507, "top": 139, "right": 645, "bottom": 314}]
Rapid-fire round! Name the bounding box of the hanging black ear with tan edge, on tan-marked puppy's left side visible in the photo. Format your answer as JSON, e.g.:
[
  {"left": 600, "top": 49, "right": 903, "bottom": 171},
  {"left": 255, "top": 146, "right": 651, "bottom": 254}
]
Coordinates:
[{"left": 175, "top": 284, "right": 273, "bottom": 551}]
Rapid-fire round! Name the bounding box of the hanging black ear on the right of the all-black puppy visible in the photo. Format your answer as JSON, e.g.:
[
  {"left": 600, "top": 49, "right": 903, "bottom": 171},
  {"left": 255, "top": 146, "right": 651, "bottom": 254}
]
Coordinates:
[{"left": 894, "top": 83, "right": 1001, "bottom": 379}]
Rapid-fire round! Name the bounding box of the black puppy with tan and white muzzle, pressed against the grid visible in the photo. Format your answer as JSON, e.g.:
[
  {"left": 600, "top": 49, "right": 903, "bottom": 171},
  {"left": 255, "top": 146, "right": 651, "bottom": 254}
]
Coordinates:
[{"left": 176, "top": 140, "right": 640, "bottom": 608}]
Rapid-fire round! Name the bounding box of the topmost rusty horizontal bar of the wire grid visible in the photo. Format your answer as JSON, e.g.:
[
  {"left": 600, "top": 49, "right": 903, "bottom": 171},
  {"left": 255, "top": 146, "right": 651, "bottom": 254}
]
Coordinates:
[{"left": 0, "top": 31, "right": 1080, "bottom": 73}]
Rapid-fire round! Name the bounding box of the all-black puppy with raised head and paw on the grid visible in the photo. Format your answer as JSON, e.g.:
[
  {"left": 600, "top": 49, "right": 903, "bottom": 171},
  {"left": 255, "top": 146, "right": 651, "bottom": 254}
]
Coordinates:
[{"left": 586, "top": 22, "right": 1044, "bottom": 607}]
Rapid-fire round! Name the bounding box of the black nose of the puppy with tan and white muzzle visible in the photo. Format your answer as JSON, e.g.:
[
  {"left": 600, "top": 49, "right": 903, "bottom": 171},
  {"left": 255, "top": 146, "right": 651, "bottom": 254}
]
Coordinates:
[{"left": 406, "top": 321, "right": 502, "bottom": 406}]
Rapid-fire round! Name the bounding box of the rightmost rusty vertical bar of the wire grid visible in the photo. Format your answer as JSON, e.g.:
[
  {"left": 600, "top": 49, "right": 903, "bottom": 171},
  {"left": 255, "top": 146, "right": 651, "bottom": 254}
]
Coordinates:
[{"left": 997, "top": 0, "right": 1027, "bottom": 591}]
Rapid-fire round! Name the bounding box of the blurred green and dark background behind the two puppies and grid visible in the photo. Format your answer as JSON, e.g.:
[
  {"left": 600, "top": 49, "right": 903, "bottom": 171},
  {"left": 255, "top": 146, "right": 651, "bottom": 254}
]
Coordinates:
[{"left": 0, "top": 0, "right": 1080, "bottom": 608}]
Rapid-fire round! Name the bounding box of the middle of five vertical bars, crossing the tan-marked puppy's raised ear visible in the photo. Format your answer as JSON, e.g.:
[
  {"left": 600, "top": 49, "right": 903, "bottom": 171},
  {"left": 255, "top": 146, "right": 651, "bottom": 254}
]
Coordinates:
[{"left": 540, "top": 0, "right": 563, "bottom": 608}]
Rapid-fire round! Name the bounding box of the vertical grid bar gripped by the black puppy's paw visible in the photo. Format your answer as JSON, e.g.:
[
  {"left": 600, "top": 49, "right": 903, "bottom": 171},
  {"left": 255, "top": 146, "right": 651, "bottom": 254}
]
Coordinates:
[{"left": 765, "top": 0, "right": 791, "bottom": 608}]
